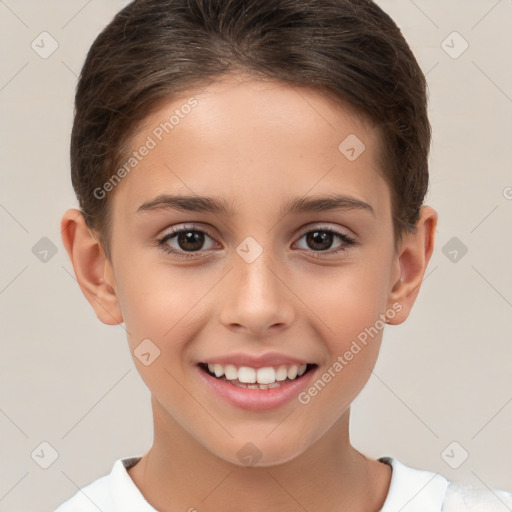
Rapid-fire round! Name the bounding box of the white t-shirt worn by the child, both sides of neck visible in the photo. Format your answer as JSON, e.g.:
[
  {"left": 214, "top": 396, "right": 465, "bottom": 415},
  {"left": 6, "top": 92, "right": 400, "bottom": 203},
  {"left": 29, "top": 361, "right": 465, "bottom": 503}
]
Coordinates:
[{"left": 55, "top": 457, "right": 512, "bottom": 512}]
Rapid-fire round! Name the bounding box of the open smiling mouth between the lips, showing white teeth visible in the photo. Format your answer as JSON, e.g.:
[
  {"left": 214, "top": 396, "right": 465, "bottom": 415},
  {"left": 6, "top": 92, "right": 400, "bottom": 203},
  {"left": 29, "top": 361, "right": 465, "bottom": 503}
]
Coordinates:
[{"left": 198, "top": 363, "right": 317, "bottom": 389}]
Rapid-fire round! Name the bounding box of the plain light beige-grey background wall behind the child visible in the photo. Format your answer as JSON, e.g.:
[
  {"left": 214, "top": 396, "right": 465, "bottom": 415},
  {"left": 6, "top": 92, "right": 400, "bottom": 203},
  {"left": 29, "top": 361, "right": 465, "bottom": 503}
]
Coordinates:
[{"left": 0, "top": 0, "right": 512, "bottom": 512}]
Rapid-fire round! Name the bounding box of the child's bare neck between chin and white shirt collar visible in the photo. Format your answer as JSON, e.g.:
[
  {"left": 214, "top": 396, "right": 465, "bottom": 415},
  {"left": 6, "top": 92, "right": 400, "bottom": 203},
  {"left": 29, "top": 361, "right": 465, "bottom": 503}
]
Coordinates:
[{"left": 129, "top": 400, "right": 391, "bottom": 512}]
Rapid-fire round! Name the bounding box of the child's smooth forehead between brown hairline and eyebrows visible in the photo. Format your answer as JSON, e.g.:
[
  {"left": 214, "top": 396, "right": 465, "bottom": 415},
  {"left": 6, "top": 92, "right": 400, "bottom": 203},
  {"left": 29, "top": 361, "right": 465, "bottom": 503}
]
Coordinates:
[{"left": 114, "top": 75, "right": 389, "bottom": 216}]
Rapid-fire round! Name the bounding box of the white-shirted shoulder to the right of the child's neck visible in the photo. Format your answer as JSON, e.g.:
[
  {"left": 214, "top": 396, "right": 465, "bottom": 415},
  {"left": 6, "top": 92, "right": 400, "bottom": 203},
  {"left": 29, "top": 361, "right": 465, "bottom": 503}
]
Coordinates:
[{"left": 378, "top": 457, "right": 512, "bottom": 512}]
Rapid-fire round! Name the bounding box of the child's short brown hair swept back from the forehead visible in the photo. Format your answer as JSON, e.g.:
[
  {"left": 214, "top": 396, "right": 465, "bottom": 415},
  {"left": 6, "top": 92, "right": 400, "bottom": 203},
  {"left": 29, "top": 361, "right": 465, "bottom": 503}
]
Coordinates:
[{"left": 71, "top": 0, "right": 431, "bottom": 258}]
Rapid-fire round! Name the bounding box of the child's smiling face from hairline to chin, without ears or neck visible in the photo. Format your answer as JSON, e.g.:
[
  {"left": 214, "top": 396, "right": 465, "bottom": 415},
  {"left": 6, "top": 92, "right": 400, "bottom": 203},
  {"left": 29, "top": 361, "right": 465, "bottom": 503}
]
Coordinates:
[{"left": 98, "top": 73, "right": 418, "bottom": 464}]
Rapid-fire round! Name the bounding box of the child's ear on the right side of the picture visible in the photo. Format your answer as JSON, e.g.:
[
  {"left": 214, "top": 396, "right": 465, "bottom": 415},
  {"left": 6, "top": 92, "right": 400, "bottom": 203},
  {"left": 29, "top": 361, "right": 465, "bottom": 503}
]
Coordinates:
[{"left": 387, "top": 206, "right": 437, "bottom": 325}]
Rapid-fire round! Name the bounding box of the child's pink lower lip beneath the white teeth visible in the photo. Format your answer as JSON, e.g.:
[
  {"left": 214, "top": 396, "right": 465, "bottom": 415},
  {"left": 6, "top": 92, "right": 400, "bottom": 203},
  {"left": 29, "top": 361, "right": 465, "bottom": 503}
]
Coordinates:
[{"left": 196, "top": 366, "right": 316, "bottom": 411}]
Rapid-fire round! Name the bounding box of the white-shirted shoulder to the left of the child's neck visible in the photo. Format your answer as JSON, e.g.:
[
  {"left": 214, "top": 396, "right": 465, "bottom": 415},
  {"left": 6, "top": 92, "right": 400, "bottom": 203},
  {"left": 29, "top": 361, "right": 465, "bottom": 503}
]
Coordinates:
[{"left": 54, "top": 457, "right": 148, "bottom": 512}]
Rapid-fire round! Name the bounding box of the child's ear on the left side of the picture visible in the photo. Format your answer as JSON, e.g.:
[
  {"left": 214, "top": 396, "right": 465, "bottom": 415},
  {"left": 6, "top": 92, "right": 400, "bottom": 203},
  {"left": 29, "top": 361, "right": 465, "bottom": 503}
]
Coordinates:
[{"left": 60, "top": 209, "right": 123, "bottom": 325}]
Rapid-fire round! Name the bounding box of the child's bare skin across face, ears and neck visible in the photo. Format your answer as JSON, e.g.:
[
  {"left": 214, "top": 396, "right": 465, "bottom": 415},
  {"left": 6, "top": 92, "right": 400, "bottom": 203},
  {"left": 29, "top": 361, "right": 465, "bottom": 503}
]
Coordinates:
[{"left": 61, "top": 75, "right": 437, "bottom": 512}]
